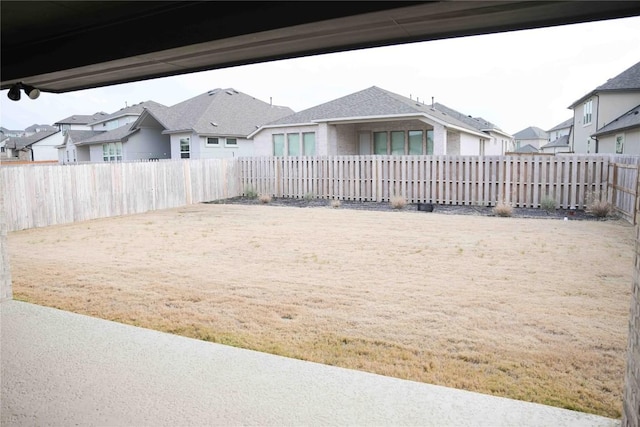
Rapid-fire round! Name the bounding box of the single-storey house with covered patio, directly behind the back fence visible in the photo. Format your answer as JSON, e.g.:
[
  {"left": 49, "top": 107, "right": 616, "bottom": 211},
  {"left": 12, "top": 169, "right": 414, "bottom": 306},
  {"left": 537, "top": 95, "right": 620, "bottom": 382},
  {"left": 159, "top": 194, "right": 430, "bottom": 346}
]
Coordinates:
[{"left": 249, "top": 86, "right": 509, "bottom": 156}]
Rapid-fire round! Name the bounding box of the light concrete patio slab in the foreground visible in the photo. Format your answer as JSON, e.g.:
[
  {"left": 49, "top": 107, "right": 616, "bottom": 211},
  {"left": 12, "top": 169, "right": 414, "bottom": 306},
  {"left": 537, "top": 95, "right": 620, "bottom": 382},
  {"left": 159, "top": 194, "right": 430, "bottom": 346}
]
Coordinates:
[{"left": 0, "top": 301, "right": 620, "bottom": 427}]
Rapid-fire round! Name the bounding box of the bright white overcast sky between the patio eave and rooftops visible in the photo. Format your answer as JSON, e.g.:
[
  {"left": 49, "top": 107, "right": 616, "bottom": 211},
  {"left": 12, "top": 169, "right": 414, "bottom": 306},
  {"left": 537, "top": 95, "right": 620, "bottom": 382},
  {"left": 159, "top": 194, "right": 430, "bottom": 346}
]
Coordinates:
[{"left": 0, "top": 17, "right": 640, "bottom": 134}]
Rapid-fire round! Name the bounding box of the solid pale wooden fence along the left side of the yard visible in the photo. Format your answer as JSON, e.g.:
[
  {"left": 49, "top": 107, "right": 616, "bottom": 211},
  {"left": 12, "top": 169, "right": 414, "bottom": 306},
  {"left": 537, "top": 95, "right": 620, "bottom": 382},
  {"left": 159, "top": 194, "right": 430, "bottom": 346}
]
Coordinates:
[{"left": 0, "top": 159, "right": 240, "bottom": 231}]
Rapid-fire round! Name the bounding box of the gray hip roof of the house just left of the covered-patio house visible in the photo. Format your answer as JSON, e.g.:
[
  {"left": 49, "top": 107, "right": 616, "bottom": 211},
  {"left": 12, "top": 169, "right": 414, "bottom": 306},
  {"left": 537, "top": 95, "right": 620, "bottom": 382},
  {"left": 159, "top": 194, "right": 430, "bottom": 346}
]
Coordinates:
[{"left": 154, "top": 89, "right": 293, "bottom": 136}]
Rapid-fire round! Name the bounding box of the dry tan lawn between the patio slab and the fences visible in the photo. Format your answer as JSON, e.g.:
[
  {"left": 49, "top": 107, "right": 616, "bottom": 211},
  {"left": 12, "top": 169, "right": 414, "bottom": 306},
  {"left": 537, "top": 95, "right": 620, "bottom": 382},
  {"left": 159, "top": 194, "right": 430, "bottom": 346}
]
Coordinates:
[{"left": 9, "top": 205, "right": 634, "bottom": 418}]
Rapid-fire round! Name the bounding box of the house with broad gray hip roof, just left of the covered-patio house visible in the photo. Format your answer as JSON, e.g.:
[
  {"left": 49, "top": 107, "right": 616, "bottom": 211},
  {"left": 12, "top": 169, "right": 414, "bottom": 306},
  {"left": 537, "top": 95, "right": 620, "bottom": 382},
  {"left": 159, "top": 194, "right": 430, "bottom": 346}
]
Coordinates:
[{"left": 130, "top": 89, "right": 293, "bottom": 159}]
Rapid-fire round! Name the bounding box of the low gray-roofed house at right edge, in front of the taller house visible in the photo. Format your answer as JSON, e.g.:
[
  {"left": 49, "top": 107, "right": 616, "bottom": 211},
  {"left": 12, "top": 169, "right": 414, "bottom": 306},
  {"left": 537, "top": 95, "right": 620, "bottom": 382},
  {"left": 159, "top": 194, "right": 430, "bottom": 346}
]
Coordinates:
[{"left": 593, "top": 105, "right": 640, "bottom": 155}]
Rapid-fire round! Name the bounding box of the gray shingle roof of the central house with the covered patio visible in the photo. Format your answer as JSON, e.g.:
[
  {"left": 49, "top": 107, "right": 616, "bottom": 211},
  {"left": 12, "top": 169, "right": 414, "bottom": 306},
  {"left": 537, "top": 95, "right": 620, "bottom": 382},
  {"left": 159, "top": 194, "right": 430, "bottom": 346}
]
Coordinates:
[{"left": 268, "top": 86, "right": 488, "bottom": 132}]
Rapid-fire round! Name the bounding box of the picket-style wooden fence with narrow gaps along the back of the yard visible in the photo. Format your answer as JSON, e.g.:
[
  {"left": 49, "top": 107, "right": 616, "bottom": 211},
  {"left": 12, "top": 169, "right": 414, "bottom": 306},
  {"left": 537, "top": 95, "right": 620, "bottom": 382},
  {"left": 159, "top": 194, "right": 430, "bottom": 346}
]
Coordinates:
[{"left": 239, "top": 156, "right": 609, "bottom": 209}]
